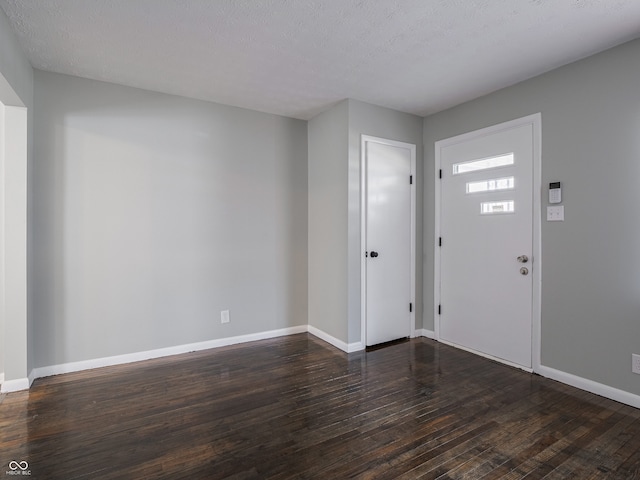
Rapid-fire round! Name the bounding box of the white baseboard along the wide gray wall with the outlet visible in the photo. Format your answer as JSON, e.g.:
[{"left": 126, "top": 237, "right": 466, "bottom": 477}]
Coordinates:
[{"left": 31, "top": 325, "right": 307, "bottom": 382}]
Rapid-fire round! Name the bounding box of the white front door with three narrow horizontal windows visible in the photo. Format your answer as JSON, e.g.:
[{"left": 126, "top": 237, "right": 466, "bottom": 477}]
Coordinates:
[{"left": 436, "top": 115, "right": 536, "bottom": 368}]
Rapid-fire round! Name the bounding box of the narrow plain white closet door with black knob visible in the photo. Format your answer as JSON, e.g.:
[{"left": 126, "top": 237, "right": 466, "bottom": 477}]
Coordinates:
[{"left": 362, "top": 136, "right": 416, "bottom": 345}]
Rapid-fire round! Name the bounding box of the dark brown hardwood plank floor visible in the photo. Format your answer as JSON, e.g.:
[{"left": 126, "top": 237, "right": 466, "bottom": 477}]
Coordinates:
[{"left": 0, "top": 334, "right": 640, "bottom": 480}]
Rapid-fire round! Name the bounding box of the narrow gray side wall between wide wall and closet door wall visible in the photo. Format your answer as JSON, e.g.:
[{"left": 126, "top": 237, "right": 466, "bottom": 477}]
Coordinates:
[{"left": 308, "top": 100, "right": 349, "bottom": 342}]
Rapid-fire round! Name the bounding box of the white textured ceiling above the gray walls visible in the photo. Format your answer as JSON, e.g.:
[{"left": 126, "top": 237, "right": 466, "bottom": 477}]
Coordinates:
[{"left": 0, "top": 0, "right": 640, "bottom": 119}]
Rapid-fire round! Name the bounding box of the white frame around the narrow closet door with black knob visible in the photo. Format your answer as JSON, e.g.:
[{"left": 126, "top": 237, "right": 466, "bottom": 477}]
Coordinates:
[{"left": 360, "top": 135, "right": 417, "bottom": 348}]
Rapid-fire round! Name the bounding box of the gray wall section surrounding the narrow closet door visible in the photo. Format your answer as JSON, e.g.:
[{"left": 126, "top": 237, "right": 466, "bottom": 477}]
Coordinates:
[{"left": 348, "top": 100, "right": 422, "bottom": 343}]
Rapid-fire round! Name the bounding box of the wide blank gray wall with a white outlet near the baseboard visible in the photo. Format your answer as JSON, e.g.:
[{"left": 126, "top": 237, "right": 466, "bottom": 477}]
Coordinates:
[{"left": 32, "top": 71, "right": 307, "bottom": 367}]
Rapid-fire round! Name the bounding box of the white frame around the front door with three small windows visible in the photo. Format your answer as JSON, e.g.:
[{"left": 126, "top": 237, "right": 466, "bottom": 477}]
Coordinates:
[{"left": 433, "top": 113, "right": 542, "bottom": 372}]
